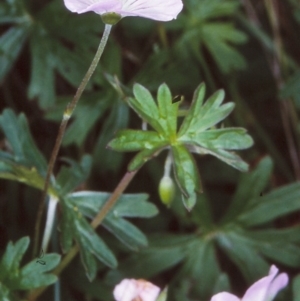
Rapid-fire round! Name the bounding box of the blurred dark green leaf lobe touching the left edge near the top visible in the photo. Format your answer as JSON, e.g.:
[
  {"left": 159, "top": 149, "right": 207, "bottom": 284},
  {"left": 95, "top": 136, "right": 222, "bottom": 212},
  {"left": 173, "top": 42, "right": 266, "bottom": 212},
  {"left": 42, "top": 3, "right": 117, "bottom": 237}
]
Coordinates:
[{"left": 0, "top": 23, "right": 30, "bottom": 83}]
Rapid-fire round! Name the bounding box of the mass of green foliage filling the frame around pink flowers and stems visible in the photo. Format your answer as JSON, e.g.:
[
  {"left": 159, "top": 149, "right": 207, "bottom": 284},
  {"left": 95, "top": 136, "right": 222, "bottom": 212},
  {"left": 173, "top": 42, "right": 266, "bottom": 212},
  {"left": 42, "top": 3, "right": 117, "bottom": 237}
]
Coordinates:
[{"left": 0, "top": 0, "right": 300, "bottom": 301}]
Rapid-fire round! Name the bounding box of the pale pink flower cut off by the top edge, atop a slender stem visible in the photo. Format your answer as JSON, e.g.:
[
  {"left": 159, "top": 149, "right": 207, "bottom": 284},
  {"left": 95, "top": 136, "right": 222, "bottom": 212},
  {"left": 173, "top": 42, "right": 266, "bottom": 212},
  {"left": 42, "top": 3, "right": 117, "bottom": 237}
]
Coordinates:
[{"left": 64, "top": 0, "right": 183, "bottom": 21}]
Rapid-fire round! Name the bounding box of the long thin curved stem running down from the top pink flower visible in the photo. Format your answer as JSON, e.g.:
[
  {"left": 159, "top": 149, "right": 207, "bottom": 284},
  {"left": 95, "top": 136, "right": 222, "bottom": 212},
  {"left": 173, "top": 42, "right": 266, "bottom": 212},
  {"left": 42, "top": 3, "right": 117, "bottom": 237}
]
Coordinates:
[{"left": 33, "top": 24, "right": 112, "bottom": 256}]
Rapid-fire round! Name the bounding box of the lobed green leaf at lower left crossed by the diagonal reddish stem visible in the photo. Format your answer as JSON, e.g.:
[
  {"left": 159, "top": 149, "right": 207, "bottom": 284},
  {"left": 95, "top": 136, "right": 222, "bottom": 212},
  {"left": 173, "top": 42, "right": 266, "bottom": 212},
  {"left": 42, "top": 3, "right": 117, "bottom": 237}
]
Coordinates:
[{"left": 60, "top": 191, "right": 158, "bottom": 280}]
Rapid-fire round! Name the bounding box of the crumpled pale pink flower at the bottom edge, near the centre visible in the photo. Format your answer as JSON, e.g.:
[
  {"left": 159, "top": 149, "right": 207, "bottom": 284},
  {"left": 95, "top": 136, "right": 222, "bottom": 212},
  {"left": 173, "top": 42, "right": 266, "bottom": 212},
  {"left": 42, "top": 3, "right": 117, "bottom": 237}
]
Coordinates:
[{"left": 114, "top": 279, "right": 160, "bottom": 301}]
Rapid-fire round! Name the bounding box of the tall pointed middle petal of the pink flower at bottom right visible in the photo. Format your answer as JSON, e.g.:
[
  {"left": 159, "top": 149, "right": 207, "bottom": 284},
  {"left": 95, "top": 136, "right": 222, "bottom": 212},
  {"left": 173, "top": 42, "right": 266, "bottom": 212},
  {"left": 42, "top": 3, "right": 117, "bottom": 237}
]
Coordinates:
[{"left": 242, "top": 265, "right": 278, "bottom": 301}]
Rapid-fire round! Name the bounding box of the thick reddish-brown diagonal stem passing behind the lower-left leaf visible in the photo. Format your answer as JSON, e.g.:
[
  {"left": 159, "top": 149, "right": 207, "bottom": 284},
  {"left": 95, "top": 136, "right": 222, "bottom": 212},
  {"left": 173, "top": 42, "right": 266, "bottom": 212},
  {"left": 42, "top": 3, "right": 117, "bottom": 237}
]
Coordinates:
[{"left": 27, "top": 170, "right": 138, "bottom": 301}]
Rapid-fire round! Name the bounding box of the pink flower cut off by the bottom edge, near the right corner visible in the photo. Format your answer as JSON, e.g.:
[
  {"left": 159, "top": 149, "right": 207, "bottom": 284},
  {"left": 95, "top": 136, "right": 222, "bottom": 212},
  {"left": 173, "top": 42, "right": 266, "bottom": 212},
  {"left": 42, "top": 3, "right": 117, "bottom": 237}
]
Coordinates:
[{"left": 211, "top": 265, "right": 289, "bottom": 301}]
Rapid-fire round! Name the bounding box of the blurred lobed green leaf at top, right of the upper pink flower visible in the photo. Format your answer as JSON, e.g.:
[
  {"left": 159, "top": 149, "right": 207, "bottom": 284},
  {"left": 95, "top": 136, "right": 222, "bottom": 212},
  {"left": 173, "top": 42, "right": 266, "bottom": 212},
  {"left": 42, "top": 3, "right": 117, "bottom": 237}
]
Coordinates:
[{"left": 181, "top": 0, "right": 247, "bottom": 73}]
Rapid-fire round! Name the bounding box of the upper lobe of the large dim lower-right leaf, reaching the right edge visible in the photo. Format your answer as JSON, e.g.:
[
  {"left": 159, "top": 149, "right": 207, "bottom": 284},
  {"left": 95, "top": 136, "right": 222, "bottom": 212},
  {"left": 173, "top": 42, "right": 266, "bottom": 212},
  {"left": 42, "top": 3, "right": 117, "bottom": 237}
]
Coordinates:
[{"left": 238, "top": 183, "right": 300, "bottom": 227}]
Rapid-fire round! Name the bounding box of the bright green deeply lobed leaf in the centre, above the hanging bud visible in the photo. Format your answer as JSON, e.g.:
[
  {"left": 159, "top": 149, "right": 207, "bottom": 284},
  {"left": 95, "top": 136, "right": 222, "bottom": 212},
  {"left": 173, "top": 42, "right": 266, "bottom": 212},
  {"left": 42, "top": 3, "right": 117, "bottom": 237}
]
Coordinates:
[{"left": 108, "top": 84, "right": 253, "bottom": 210}]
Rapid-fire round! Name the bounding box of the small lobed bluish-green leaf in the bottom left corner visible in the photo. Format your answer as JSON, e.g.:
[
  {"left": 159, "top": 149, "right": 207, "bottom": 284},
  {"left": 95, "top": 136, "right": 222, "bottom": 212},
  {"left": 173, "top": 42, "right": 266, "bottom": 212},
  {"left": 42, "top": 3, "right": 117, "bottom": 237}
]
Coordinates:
[{"left": 0, "top": 237, "right": 60, "bottom": 292}]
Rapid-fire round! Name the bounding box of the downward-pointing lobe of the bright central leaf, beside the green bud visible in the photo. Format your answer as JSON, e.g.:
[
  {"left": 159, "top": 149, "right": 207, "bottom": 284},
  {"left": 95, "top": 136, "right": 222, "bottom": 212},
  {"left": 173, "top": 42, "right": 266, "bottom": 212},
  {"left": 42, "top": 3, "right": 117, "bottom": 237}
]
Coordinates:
[{"left": 172, "top": 145, "right": 202, "bottom": 210}]
